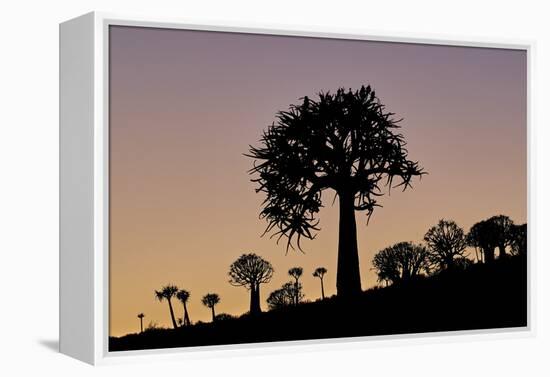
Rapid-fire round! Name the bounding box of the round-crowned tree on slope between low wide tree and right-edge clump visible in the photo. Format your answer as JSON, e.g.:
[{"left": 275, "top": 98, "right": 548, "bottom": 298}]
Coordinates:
[{"left": 424, "top": 220, "right": 468, "bottom": 270}]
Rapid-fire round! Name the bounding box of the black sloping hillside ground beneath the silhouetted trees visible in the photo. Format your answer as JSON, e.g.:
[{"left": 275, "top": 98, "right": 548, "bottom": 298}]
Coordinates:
[{"left": 109, "top": 257, "right": 527, "bottom": 351}]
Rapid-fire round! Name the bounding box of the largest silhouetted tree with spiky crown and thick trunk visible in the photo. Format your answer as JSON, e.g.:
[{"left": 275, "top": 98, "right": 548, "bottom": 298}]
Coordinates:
[{"left": 247, "top": 86, "right": 424, "bottom": 297}]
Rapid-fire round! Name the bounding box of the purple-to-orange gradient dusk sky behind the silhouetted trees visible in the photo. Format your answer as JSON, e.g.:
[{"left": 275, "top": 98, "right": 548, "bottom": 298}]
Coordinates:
[{"left": 110, "top": 27, "right": 527, "bottom": 336}]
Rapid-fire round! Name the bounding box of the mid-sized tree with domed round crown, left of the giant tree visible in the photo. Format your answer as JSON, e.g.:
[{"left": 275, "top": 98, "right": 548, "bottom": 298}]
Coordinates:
[{"left": 229, "top": 254, "right": 273, "bottom": 314}]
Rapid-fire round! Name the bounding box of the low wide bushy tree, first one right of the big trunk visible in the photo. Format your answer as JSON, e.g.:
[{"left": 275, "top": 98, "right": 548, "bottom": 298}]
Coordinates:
[{"left": 372, "top": 242, "right": 431, "bottom": 284}]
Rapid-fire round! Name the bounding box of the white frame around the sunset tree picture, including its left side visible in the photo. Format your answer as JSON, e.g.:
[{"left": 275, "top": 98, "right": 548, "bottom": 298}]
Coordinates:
[{"left": 60, "top": 12, "right": 535, "bottom": 364}]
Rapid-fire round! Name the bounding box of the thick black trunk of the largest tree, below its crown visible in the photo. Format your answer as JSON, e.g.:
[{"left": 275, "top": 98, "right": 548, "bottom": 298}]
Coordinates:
[{"left": 336, "top": 191, "right": 361, "bottom": 298}]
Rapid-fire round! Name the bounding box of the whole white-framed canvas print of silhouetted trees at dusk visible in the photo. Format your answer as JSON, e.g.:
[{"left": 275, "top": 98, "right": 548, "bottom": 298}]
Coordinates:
[{"left": 60, "top": 13, "right": 532, "bottom": 363}]
